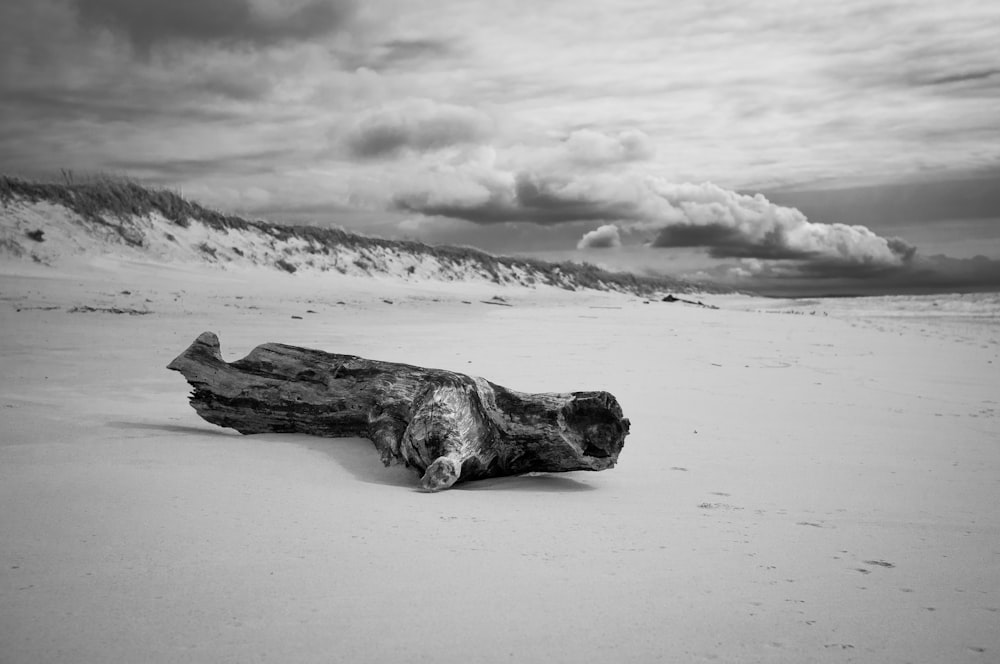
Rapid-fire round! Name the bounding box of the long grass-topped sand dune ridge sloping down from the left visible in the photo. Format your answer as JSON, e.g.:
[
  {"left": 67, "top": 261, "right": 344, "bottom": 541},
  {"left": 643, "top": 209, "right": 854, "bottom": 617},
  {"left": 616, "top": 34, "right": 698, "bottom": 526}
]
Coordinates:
[{"left": 0, "top": 176, "right": 721, "bottom": 295}]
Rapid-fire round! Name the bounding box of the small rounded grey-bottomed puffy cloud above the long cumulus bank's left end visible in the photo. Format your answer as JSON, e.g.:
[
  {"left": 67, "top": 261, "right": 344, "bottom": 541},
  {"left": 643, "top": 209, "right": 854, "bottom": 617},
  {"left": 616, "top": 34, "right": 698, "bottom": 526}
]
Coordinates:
[{"left": 347, "top": 99, "right": 494, "bottom": 158}]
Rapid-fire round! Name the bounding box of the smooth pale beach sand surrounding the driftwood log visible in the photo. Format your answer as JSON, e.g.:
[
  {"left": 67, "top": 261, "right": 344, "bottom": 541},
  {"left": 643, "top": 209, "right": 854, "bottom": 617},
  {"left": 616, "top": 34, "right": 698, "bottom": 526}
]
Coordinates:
[{"left": 0, "top": 260, "right": 1000, "bottom": 664}]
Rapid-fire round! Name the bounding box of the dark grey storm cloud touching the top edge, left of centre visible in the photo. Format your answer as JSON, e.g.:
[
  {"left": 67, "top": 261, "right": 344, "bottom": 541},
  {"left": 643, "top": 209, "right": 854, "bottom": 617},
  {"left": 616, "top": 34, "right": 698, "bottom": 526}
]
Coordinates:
[{"left": 75, "top": 0, "right": 352, "bottom": 52}]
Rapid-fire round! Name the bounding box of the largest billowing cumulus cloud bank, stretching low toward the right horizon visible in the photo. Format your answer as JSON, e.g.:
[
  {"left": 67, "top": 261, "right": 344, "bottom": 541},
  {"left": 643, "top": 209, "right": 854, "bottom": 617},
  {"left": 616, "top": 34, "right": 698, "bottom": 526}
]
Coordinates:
[{"left": 395, "top": 163, "right": 915, "bottom": 274}]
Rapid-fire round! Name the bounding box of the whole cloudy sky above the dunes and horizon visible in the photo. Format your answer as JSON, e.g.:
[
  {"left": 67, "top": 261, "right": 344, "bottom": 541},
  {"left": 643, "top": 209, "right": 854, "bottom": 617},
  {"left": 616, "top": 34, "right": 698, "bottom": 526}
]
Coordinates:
[{"left": 0, "top": 0, "right": 1000, "bottom": 292}]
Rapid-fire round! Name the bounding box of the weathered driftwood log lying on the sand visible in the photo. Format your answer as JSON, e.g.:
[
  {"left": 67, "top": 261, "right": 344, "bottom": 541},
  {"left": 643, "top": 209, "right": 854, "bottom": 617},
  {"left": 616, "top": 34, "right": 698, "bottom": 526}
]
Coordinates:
[{"left": 167, "top": 332, "right": 629, "bottom": 491}]
